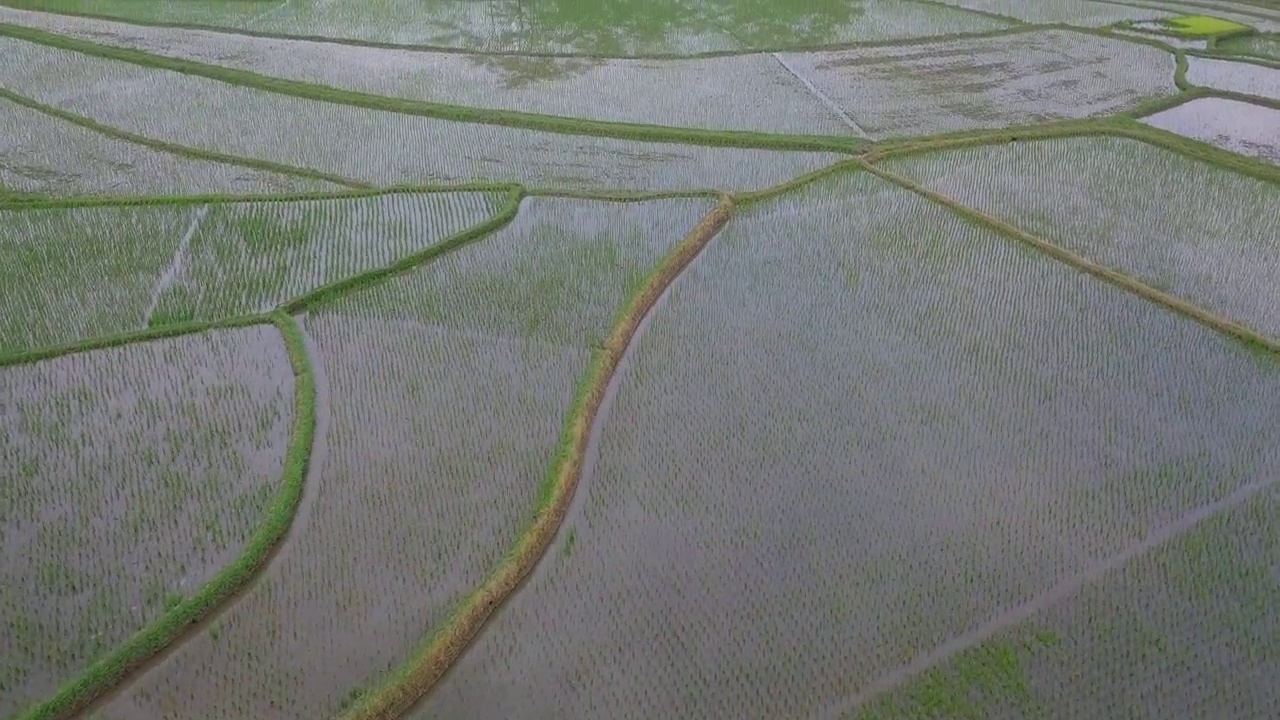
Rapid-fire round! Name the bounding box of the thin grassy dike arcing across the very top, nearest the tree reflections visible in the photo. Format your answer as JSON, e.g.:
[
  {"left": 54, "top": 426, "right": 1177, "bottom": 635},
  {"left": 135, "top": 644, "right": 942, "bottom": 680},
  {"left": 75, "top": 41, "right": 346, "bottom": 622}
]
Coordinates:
[{"left": 0, "top": 0, "right": 1041, "bottom": 60}]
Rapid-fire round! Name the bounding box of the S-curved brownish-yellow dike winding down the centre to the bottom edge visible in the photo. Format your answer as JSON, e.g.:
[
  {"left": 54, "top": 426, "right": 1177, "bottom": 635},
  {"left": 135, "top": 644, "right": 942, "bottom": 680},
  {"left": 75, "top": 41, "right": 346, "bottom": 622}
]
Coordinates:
[{"left": 342, "top": 196, "right": 733, "bottom": 720}]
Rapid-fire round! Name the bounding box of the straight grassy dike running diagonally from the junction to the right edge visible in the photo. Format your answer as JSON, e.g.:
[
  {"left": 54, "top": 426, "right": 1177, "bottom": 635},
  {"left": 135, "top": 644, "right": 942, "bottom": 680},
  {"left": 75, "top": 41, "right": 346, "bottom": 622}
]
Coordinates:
[{"left": 867, "top": 163, "right": 1280, "bottom": 360}]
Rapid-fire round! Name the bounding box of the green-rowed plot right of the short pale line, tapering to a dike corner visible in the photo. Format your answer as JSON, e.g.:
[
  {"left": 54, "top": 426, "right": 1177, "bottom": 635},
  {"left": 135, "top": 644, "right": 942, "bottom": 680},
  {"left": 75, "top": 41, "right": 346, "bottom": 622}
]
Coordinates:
[{"left": 146, "top": 192, "right": 503, "bottom": 324}]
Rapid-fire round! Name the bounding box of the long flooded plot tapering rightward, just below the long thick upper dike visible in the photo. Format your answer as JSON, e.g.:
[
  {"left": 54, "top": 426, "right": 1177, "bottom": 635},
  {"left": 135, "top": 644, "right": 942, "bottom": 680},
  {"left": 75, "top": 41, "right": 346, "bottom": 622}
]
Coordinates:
[{"left": 0, "top": 34, "right": 840, "bottom": 190}]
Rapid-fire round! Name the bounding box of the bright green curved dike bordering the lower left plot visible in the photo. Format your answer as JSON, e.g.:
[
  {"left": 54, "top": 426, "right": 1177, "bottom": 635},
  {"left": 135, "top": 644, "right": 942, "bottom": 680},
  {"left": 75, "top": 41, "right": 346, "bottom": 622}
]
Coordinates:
[{"left": 8, "top": 313, "right": 315, "bottom": 720}]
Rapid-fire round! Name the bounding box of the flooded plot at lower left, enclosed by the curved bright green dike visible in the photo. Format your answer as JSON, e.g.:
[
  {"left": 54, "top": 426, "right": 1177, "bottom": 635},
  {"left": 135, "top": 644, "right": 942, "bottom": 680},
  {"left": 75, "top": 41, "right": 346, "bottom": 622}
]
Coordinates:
[{"left": 0, "top": 327, "right": 293, "bottom": 717}]
